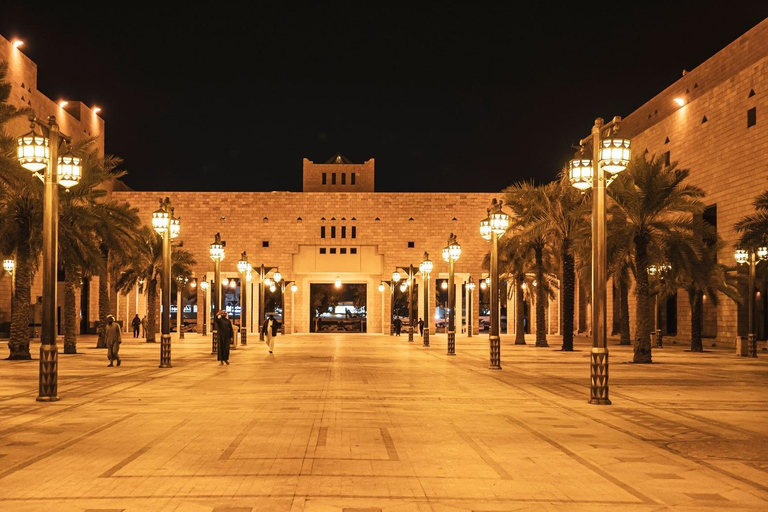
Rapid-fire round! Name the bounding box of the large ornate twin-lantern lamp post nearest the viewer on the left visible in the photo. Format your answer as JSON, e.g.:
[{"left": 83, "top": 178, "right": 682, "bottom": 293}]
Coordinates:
[{"left": 17, "top": 116, "right": 82, "bottom": 402}]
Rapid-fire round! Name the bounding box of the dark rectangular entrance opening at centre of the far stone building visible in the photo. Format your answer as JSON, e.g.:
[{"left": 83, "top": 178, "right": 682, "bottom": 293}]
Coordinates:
[{"left": 309, "top": 283, "right": 368, "bottom": 333}]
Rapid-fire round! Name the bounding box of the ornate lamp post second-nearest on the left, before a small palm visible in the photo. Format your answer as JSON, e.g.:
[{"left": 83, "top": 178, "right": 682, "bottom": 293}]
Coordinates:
[{"left": 152, "top": 197, "right": 180, "bottom": 368}]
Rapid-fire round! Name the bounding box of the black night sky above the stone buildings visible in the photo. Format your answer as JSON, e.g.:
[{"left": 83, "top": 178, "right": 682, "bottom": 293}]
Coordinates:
[{"left": 0, "top": 1, "right": 768, "bottom": 192}]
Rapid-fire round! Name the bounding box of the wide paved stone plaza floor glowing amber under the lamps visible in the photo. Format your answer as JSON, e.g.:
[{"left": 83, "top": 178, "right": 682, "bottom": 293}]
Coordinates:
[{"left": 0, "top": 334, "right": 768, "bottom": 512}]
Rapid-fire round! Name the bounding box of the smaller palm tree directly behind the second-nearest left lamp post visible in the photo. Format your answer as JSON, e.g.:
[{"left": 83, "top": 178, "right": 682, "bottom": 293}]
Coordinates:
[{"left": 115, "top": 226, "right": 197, "bottom": 342}]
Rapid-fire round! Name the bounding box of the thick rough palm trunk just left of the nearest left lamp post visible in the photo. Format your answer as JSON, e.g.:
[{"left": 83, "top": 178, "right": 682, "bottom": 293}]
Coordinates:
[{"left": 8, "top": 244, "right": 33, "bottom": 359}]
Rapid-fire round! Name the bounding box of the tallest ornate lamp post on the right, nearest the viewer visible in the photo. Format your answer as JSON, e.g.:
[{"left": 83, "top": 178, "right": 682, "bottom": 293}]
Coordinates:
[{"left": 568, "top": 116, "right": 630, "bottom": 405}]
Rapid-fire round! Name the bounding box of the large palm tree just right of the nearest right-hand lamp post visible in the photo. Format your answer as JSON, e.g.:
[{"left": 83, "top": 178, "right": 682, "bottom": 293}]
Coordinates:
[{"left": 608, "top": 156, "right": 704, "bottom": 363}]
